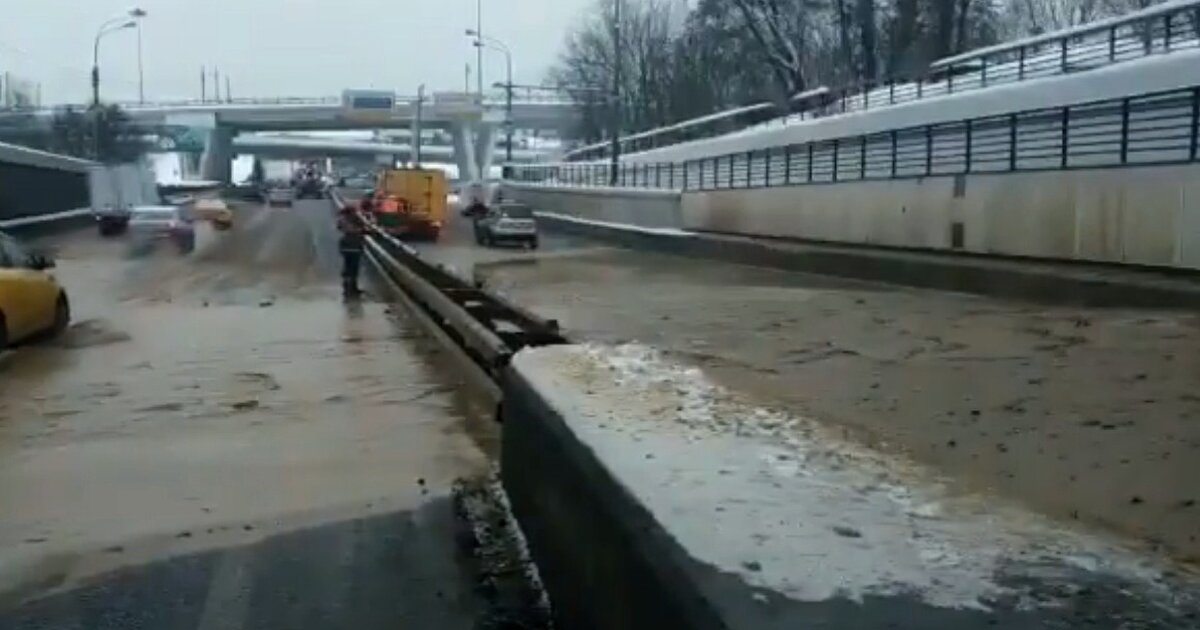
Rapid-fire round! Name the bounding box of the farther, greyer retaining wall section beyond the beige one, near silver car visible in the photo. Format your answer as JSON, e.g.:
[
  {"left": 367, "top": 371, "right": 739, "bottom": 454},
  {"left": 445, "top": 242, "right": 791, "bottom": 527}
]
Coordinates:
[{"left": 504, "top": 182, "right": 683, "bottom": 228}]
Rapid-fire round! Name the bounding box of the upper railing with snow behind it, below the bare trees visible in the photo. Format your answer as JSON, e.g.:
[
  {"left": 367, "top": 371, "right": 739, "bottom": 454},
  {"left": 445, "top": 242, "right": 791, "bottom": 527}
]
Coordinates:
[{"left": 566, "top": 0, "right": 1200, "bottom": 161}]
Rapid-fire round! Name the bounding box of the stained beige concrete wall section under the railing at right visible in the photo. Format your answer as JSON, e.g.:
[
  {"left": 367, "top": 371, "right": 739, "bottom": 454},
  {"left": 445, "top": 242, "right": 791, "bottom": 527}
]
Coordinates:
[{"left": 683, "top": 164, "right": 1200, "bottom": 269}]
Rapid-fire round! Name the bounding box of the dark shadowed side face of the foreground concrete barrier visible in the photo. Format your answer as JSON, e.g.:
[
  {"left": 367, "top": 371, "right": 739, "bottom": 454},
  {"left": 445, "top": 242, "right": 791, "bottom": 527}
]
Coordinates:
[{"left": 500, "top": 357, "right": 720, "bottom": 630}]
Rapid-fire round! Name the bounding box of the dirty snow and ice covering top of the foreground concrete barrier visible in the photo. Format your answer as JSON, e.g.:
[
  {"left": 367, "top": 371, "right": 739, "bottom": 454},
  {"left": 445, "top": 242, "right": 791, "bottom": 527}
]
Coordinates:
[{"left": 512, "top": 343, "right": 1200, "bottom": 611}]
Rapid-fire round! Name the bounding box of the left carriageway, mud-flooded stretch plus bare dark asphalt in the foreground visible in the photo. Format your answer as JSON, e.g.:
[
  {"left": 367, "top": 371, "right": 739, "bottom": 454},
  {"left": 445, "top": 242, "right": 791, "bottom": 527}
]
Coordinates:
[{"left": 0, "top": 202, "right": 494, "bottom": 629}]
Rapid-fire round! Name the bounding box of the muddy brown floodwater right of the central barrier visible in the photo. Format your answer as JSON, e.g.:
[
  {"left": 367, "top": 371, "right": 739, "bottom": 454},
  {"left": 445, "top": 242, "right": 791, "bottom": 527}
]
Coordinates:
[{"left": 481, "top": 251, "right": 1200, "bottom": 563}]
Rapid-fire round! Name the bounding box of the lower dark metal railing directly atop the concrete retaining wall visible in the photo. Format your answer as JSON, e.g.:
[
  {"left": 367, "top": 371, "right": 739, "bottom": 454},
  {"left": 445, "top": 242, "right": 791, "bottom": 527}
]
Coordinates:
[{"left": 510, "top": 86, "right": 1200, "bottom": 191}]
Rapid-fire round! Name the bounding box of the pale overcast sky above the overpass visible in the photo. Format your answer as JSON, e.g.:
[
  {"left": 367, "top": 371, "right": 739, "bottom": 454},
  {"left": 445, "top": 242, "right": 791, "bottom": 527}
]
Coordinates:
[{"left": 0, "top": 0, "right": 594, "bottom": 102}]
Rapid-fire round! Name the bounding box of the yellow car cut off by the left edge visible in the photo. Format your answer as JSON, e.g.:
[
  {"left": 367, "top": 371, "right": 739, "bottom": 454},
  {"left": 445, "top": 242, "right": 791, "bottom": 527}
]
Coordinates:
[{"left": 0, "top": 232, "right": 71, "bottom": 350}]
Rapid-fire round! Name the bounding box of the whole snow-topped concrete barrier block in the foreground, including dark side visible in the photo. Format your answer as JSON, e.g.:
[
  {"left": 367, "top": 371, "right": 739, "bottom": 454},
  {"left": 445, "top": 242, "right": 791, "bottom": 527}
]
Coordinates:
[{"left": 502, "top": 346, "right": 1200, "bottom": 630}]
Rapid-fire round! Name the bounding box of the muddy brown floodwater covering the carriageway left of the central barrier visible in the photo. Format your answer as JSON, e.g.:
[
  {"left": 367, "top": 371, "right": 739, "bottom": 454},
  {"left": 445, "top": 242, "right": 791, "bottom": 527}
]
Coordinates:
[{"left": 0, "top": 202, "right": 494, "bottom": 628}]
